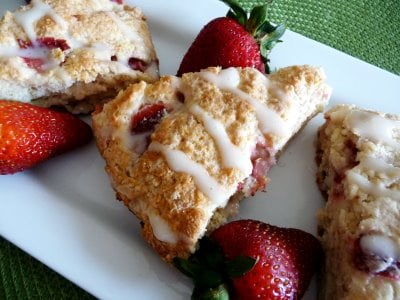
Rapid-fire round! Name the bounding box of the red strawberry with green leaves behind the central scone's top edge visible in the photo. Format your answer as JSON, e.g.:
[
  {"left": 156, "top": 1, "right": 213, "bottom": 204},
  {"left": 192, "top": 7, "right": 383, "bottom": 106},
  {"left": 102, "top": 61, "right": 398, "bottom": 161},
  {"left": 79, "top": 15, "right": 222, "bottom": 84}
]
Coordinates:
[{"left": 177, "top": 0, "right": 285, "bottom": 76}]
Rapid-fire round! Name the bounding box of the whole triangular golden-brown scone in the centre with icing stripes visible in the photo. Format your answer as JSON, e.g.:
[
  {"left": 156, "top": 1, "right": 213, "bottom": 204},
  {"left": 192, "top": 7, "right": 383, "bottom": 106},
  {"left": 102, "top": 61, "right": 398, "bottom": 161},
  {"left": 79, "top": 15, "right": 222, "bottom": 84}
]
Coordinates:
[{"left": 93, "top": 66, "right": 330, "bottom": 261}]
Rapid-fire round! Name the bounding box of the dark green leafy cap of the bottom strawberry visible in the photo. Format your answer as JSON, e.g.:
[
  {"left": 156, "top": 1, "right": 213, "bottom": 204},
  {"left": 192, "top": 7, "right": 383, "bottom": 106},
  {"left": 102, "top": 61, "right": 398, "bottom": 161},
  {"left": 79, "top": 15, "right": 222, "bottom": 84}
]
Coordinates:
[{"left": 174, "top": 237, "right": 256, "bottom": 300}]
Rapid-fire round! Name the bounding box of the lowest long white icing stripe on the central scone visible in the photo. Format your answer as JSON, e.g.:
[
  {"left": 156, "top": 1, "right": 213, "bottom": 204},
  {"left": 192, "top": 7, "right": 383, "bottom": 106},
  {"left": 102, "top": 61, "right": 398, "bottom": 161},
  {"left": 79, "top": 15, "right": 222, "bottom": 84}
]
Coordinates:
[{"left": 148, "top": 142, "right": 236, "bottom": 211}]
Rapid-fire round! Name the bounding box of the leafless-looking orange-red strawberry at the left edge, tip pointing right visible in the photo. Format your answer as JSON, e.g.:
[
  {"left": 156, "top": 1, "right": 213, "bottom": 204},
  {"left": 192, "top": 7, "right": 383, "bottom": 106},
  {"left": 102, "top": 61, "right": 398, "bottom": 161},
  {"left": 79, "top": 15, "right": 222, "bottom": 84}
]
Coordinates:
[{"left": 0, "top": 100, "right": 92, "bottom": 175}]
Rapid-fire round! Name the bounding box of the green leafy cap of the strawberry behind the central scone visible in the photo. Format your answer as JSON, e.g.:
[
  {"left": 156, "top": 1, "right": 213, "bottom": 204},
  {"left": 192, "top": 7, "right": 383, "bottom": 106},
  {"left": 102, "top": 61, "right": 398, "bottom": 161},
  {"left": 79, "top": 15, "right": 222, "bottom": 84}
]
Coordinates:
[{"left": 221, "top": 0, "right": 286, "bottom": 73}]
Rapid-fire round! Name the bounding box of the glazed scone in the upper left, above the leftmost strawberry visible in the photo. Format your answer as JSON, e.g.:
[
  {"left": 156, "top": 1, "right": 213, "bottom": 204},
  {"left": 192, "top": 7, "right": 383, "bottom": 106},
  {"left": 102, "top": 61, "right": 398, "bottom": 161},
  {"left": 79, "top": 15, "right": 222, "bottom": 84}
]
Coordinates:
[{"left": 0, "top": 0, "right": 159, "bottom": 113}]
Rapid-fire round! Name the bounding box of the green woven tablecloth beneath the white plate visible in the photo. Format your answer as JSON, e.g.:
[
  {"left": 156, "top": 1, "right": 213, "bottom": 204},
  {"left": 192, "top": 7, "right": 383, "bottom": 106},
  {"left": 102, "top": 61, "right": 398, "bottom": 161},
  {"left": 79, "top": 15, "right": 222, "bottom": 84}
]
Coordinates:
[{"left": 0, "top": 0, "right": 400, "bottom": 299}]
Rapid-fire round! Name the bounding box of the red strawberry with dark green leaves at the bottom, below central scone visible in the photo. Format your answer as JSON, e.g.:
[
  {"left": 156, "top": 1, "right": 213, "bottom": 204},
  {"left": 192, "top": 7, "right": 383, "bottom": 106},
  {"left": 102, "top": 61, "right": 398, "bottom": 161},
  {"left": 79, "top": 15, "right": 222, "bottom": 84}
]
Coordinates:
[{"left": 175, "top": 220, "right": 322, "bottom": 300}]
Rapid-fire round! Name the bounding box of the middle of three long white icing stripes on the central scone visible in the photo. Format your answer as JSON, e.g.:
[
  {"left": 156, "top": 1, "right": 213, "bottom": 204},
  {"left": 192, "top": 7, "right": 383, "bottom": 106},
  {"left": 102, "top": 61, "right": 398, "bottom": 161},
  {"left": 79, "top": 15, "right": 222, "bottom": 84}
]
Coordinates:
[{"left": 189, "top": 105, "right": 253, "bottom": 176}]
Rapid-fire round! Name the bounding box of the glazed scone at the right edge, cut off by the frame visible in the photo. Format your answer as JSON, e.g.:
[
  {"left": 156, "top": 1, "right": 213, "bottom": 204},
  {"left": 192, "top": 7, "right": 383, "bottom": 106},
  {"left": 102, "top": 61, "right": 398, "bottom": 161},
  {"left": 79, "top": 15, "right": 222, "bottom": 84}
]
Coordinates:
[{"left": 317, "top": 105, "right": 400, "bottom": 300}]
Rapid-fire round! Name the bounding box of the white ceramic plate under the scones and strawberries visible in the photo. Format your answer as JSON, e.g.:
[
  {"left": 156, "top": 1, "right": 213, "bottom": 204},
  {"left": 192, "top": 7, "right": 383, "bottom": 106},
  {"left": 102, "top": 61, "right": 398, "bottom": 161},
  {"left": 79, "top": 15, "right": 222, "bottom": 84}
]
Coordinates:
[{"left": 0, "top": 0, "right": 400, "bottom": 300}]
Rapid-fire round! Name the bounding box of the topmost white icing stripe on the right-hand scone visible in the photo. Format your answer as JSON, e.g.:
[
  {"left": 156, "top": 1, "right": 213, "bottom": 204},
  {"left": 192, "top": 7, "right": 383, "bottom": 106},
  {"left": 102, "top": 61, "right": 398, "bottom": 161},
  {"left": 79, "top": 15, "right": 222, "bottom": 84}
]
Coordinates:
[{"left": 346, "top": 111, "right": 400, "bottom": 149}]
